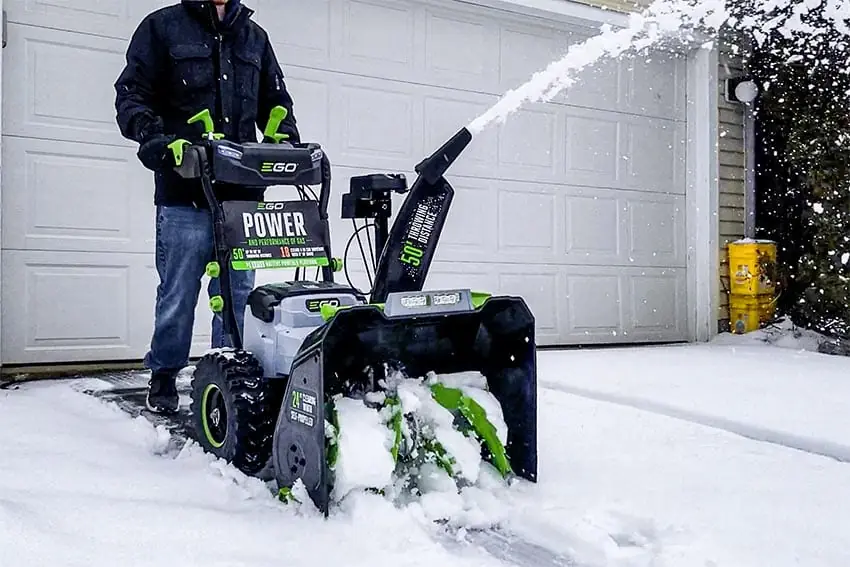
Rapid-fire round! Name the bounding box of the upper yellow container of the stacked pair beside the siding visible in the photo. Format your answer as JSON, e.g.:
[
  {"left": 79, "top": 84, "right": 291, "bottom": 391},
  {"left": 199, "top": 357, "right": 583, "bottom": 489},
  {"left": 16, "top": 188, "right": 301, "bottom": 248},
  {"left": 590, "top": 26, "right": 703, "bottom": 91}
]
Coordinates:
[{"left": 729, "top": 239, "right": 776, "bottom": 296}]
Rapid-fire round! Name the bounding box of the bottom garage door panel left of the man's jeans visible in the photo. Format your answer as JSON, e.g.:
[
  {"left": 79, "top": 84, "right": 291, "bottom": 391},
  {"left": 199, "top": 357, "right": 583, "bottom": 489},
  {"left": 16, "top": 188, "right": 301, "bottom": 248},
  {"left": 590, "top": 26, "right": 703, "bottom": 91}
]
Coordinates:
[{"left": 2, "top": 250, "right": 151, "bottom": 363}]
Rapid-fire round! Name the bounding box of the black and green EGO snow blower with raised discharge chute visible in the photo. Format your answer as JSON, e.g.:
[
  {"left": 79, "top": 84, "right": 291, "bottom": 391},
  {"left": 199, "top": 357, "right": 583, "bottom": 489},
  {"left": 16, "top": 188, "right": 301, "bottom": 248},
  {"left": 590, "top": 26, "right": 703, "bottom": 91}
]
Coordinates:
[{"left": 171, "top": 107, "right": 537, "bottom": 515}]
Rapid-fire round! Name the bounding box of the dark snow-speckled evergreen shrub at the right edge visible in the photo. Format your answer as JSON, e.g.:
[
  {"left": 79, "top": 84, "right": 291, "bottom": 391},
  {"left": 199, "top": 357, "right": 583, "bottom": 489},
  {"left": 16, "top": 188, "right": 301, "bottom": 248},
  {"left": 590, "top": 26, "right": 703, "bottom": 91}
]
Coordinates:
[{"left": 749, "top": 21, "right": 850, "bottom": 337}]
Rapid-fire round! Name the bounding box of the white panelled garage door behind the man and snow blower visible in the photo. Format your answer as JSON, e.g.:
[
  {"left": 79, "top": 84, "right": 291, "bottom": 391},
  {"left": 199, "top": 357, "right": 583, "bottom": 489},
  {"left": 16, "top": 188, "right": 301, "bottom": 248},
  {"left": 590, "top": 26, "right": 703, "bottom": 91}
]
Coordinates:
[{"left": 2, "top": 0, "right": 689, "bottom": 364}]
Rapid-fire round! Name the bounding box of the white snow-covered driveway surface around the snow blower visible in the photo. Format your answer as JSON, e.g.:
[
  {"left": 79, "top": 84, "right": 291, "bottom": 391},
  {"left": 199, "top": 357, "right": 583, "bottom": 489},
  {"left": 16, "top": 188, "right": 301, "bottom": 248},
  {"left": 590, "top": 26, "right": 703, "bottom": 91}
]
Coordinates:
[{"left": 0, "top": 328, "right": 850, "bottom": 567}]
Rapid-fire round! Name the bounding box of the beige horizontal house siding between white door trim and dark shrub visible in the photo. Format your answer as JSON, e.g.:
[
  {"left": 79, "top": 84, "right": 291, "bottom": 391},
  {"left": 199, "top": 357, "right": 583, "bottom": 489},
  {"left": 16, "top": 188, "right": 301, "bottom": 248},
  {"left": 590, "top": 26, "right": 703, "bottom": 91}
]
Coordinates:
[{"left": 566, "top": 0, "right": 746, "bottom": 331}]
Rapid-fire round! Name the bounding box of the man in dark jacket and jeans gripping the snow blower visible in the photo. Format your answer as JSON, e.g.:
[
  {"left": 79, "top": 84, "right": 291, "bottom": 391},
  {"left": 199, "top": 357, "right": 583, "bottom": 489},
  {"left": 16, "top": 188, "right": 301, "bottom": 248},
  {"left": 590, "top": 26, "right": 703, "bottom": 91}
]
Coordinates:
[{"left": 115, "top": 0, "right": 300, "bottom": 413}]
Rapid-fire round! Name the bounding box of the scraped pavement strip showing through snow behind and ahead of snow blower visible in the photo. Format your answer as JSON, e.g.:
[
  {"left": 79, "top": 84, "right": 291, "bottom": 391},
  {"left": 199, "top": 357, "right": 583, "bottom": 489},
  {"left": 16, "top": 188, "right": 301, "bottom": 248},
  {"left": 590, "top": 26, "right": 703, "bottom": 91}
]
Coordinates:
[{"left": 75, "top": 369, "right": 580, "bottom": 567}]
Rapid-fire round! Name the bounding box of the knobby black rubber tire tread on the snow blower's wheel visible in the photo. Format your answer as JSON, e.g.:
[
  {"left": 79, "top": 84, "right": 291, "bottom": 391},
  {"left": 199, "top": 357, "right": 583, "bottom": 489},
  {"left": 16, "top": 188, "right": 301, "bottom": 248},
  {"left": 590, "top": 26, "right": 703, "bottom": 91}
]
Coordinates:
[{"left": 192, "top": 352, "right": 277, "bottom": 475}]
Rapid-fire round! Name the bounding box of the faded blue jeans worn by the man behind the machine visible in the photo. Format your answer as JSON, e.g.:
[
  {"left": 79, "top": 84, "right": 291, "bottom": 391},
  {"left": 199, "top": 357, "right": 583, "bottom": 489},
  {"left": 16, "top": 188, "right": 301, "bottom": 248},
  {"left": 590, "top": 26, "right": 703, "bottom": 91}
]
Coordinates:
[{"left": 145, "top": 206, "right": 254, "bottom": 372}]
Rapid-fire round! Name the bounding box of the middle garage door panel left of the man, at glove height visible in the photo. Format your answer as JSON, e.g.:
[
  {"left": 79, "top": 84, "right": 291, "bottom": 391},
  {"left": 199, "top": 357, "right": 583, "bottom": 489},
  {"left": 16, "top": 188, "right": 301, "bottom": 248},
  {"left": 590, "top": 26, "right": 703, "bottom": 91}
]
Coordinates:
[{"left": 2, "top": 138, "right": 154, "bottom": 252}]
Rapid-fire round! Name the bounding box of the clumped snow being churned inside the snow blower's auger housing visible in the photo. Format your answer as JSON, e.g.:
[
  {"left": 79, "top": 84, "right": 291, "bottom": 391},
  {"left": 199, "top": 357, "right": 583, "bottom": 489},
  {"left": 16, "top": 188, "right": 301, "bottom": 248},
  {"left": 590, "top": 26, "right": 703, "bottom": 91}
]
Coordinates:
[{"left": 327, "top": 372, "right": 508, "bottom": 520}]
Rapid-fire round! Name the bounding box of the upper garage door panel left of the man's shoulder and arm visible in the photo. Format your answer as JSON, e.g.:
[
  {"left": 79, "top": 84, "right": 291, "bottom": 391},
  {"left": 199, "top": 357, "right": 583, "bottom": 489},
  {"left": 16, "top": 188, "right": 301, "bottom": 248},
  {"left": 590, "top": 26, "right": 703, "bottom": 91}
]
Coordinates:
[{"left": 3, "top": 24, "right": 129, "bottom": 146}]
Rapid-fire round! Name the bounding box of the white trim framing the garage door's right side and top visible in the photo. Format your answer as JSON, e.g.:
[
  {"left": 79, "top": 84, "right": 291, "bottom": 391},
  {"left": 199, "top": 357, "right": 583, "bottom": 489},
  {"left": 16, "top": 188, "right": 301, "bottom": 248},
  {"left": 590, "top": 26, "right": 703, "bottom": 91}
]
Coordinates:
[{"left": 0, "top": 0, "right": 719, "bottom": 367}]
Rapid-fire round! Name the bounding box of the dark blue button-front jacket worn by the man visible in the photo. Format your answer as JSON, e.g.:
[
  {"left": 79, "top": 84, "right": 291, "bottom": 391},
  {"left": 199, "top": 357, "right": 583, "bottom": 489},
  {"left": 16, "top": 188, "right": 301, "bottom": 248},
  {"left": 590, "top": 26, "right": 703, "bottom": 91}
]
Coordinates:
[{"left": 115, "top": 0, "right": 300, "bottom": 207}]
